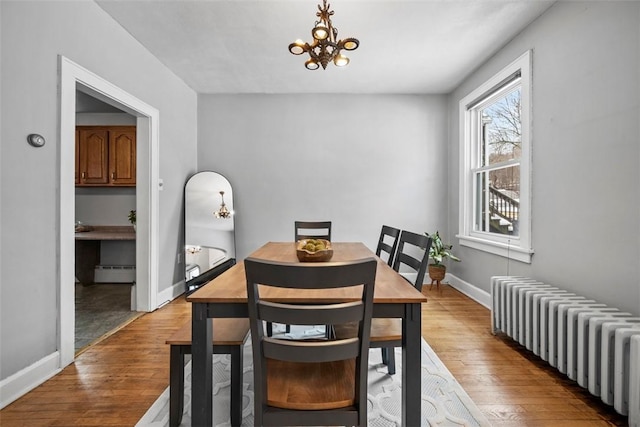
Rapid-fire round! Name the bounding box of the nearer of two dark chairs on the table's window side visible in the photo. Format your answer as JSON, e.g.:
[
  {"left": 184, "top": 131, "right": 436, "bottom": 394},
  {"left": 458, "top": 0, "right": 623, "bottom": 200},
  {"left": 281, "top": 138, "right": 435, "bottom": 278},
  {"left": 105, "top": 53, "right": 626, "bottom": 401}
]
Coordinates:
[{"left": 333, "top": 230, "right": 431, "bottom": 375}]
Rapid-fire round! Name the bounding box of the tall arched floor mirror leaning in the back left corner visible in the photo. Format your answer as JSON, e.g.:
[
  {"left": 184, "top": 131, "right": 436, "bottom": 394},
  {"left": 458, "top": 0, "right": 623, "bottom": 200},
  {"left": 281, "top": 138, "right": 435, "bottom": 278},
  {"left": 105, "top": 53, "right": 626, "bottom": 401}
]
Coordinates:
[{"left": 184, "top": 171, "right": 236, "bottom": 295}]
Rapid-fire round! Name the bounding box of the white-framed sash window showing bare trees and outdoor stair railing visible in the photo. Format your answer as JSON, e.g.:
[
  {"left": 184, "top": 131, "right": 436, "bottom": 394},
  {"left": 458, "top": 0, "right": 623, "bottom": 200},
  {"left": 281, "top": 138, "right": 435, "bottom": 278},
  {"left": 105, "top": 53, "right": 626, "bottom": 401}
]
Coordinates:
[{"left": 458, "top": 52, "right": 533, "bottom": 262}]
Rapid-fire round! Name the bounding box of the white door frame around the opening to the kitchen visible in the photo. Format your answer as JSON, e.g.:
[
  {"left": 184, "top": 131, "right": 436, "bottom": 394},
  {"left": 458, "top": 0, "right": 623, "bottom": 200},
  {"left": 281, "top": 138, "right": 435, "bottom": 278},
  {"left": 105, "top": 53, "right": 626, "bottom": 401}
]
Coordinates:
[{"left": 57, "top": 56, "right": 159, "bottom": 368}]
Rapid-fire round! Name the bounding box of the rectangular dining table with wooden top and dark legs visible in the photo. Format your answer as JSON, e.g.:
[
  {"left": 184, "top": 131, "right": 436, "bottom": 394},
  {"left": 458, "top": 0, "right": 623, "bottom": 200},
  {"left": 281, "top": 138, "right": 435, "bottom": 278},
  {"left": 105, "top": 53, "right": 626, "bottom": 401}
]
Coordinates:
[{"left": 186, "top": 242, "right": 427, "bottom": 426}]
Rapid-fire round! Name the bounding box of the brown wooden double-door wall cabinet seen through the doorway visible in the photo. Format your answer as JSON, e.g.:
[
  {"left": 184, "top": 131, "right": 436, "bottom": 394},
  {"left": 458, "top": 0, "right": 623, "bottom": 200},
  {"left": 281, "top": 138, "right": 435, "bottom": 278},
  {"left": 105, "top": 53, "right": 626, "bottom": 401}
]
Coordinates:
[{"left": 76, "top": 126, "right": 136, "bottom": 187}]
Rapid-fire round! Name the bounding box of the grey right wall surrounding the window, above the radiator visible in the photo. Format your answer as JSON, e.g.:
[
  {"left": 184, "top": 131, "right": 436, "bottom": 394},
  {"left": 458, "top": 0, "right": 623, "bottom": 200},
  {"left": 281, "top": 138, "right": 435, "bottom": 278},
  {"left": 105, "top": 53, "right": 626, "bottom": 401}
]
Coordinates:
[{"left": 448, "top": 1, "right": 640, "bottom": 315}]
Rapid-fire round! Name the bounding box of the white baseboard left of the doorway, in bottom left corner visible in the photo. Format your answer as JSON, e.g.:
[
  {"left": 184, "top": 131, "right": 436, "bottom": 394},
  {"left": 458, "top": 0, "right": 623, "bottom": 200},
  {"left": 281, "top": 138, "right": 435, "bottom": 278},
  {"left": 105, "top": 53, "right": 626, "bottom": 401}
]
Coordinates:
[{"left": 0, "top": 351, "right": 62, "bottom": 409}]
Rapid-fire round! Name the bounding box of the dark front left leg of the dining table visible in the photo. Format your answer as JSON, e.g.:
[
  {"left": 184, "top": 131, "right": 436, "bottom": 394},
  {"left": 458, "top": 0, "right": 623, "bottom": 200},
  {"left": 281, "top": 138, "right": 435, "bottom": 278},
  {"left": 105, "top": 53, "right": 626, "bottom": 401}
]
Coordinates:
[{"left": 191, "top": 303, "right": 213, "bottom": 427}]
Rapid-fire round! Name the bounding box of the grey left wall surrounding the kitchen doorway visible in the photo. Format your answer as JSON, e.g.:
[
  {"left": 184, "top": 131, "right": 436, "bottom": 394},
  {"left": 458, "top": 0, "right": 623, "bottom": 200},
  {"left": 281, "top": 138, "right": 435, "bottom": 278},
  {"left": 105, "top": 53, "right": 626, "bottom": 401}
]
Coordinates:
[{"left": 0, "top": 0, "right": 197, "bottom": 386}]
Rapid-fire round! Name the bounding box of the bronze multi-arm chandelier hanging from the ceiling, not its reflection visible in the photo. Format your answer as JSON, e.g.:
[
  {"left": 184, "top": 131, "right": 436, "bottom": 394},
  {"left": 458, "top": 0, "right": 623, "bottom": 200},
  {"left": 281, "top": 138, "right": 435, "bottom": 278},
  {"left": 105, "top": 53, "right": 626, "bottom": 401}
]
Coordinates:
[{"left": 289, "top": 0, "right": 360, "bottom": 70}]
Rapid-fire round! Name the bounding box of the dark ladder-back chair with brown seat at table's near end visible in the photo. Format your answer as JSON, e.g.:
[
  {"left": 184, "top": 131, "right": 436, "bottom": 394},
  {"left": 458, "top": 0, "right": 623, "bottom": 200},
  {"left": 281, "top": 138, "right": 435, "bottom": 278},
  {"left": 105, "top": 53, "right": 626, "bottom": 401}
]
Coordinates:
[{"left": 244, "top": 258, "right": 377, "bottom": 426}]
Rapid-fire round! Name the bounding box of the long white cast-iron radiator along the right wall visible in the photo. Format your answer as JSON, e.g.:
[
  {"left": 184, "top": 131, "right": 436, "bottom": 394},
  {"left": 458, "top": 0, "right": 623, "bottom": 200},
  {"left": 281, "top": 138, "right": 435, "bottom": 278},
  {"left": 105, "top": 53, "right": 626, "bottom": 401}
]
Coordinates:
[{"left": 491, "top": 276, "right": 640, "bottom": 427}]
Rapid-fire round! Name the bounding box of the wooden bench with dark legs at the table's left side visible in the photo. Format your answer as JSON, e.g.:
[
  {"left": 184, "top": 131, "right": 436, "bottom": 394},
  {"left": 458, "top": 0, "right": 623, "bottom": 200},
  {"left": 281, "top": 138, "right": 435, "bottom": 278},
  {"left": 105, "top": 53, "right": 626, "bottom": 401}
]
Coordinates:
[{"left": 166, "top": 318, "right": 249, "bottom": 427}]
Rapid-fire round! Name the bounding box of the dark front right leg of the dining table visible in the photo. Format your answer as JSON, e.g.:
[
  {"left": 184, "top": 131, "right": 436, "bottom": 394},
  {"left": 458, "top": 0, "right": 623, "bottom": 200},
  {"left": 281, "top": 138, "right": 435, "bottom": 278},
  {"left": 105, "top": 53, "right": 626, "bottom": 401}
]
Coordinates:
[{"left": 402, "top": 304, "right": 422, "bottom": 426}]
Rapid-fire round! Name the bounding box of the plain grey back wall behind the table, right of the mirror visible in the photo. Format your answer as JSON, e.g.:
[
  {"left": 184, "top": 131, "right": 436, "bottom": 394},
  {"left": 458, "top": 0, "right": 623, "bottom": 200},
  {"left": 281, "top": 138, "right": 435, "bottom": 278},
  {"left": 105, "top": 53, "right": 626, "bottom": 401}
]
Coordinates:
[{"left": 198, "top": 95, "right": 447, "bottom": 259}]
